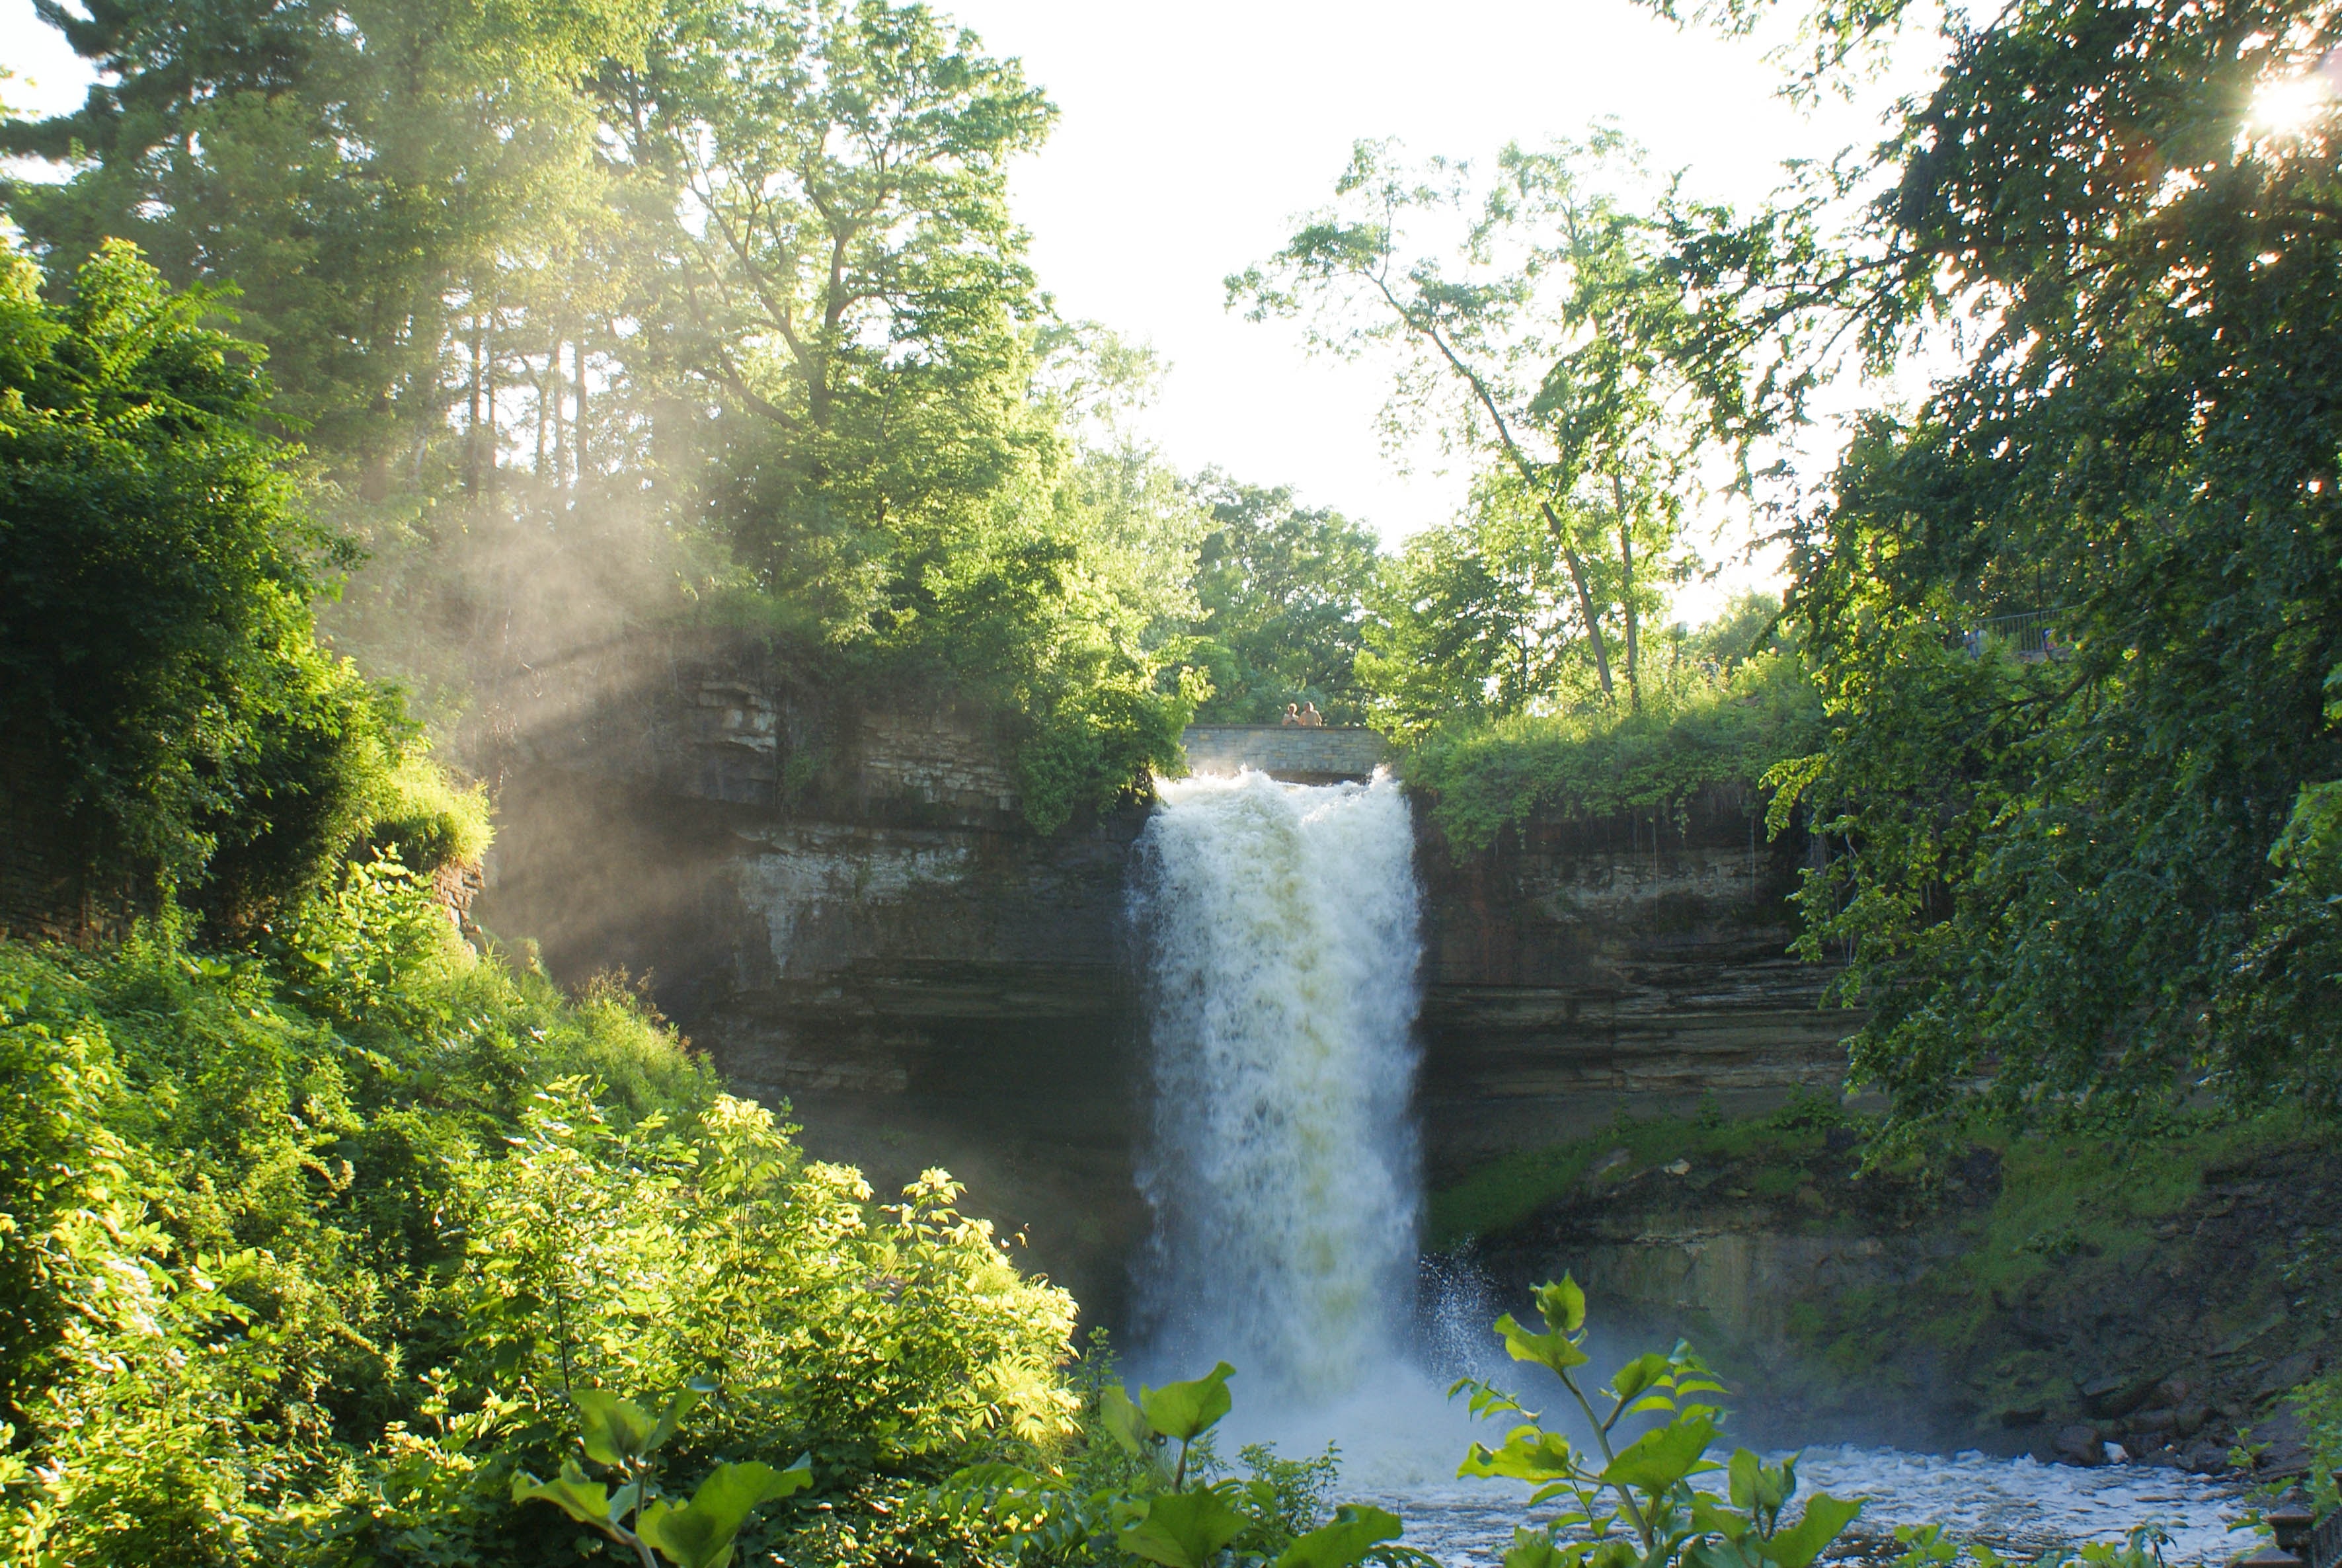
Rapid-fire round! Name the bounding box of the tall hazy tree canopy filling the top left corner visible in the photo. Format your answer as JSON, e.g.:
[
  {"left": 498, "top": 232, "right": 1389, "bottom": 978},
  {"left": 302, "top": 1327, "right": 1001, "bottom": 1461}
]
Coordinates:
[{"left": 0, "top": 0, "right": 642, "bottom": 485}]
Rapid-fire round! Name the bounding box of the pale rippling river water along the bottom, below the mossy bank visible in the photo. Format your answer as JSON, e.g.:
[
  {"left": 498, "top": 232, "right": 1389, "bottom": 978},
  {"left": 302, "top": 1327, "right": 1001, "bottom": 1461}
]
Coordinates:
[{"left": 1345, "top": 1448, "right": 2253, "bottom": 1568}]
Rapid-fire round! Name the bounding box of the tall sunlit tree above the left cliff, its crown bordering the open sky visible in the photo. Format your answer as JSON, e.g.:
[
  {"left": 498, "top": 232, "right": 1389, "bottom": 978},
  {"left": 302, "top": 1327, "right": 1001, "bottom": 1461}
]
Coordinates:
[{"left": 613, "top": 0, "right": 1056, "bottom": 637}]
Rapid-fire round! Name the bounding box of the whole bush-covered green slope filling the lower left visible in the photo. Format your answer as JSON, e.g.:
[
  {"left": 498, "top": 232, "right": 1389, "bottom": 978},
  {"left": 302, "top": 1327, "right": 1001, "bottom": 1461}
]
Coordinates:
[{"left": 0, "top": 858, "right": 1073, "bottom": 1568}]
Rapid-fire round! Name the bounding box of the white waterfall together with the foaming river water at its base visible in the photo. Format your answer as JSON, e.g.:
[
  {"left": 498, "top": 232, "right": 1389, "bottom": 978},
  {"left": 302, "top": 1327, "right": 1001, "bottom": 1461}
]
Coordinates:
[{"left": 1131, "top": 771, "right": 2239, "bottom": 1568}]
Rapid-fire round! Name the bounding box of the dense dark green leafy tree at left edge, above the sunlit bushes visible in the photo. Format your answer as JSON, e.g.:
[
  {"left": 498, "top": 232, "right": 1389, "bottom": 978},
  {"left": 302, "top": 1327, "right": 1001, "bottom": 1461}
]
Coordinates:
[{"left": 0, "top": 241, "right": 430, "bottom": 921}]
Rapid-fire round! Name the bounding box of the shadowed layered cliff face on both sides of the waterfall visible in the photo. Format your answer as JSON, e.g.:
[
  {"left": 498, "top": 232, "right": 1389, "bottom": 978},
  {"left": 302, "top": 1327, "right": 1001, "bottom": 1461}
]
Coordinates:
[{"left": 475, "top": 645, "right": 1843, "bottom": 1324}]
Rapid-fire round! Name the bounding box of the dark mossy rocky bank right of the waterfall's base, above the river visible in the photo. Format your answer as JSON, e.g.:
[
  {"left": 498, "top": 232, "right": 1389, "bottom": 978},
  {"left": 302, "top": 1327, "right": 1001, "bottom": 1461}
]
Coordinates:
[{"left": 1433, "top": 1101, "right": 2342, "bottom": 1474}]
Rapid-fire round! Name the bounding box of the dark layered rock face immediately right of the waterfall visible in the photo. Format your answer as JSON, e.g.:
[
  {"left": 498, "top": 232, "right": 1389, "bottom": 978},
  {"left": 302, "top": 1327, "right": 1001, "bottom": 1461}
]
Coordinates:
[{"left": 1417, "top": 792, "right": 1853, "bottom": 1174}]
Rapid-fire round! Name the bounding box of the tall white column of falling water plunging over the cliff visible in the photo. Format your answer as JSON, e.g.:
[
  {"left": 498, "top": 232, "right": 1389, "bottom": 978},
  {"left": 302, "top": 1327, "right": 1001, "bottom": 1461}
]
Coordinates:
[{"left": 1131, "top": 771, "right": 1422, "bottom": 1406}]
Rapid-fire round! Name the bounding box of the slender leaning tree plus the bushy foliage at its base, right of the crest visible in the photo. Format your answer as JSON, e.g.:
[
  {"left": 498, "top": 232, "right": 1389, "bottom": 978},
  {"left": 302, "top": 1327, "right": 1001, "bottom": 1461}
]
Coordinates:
[{"left": 1228, "top": 124, "right": 1794, "bottom": 707}]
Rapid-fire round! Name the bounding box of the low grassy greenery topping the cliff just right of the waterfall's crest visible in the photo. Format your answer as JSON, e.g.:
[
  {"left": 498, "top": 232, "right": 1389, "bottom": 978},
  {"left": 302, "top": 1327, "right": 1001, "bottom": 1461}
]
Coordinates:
[{"left": 1405, "top": 652, "right": 1822, "bottom": 853}]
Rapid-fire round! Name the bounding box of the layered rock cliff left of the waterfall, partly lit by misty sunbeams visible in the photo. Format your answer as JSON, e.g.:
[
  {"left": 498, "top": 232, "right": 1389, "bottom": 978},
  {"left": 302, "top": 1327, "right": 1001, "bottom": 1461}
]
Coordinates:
[{"left": 475, "top": 645, "right": 1143, "bottom": 1319}]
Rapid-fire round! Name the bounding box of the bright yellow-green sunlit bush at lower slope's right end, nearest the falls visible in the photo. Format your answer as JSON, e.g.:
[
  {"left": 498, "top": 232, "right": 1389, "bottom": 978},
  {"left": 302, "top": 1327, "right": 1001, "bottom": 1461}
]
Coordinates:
[{"left": 449, "top": 1081, "right": 1073, "bottom": 1470}]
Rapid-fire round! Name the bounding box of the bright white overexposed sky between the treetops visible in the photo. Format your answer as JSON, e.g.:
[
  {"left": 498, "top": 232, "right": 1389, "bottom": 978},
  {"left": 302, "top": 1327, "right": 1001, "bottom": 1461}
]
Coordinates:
[{"left": 0, "top": 0, "right": 1916, "bottom": 616}]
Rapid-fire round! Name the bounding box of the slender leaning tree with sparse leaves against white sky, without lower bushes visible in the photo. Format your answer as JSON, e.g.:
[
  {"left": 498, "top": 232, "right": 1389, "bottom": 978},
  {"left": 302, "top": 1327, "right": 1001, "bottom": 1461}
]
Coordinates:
[{"left": 1228, "top": 129, "right": 1747, "bottom": 703}]
